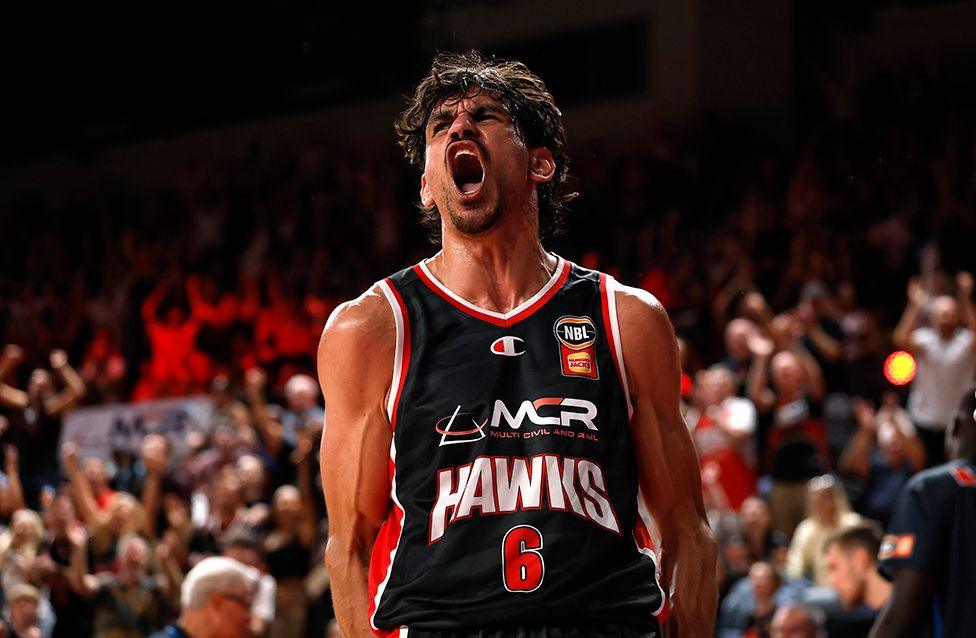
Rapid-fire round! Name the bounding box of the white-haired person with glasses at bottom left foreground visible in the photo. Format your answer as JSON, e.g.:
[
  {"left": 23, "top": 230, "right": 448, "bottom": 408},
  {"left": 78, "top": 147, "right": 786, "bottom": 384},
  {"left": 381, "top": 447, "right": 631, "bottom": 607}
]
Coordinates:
[{"left": 150, "top": 556, "right": 258, "bottom": 638}]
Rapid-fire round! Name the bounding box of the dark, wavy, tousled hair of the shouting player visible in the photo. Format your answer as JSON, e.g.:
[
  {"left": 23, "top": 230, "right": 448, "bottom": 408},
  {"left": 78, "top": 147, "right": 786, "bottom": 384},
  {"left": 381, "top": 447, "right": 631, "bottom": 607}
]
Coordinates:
[{"left": 395, "top": 50, "right": 578, "bottom": 243}]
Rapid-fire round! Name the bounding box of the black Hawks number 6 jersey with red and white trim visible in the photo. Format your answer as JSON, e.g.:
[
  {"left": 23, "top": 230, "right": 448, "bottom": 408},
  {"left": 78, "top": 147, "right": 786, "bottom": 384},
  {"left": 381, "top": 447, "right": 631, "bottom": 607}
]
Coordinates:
[{"left": 369, "top": 257, "right": 668, "bottom": 635}]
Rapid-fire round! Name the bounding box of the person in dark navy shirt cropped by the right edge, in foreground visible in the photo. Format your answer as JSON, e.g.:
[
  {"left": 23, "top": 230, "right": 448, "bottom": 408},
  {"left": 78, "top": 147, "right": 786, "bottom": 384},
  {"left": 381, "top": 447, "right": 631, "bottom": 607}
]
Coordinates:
[{"left": 871, "top": 388, "right": 976, "bottom": 638}]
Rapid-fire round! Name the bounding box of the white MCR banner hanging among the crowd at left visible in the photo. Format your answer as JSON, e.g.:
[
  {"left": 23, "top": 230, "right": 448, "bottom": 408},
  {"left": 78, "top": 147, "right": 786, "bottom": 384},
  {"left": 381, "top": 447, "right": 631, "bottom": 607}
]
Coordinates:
[{"left": 61, "top": 395, "right": 214, "bottom": 461}]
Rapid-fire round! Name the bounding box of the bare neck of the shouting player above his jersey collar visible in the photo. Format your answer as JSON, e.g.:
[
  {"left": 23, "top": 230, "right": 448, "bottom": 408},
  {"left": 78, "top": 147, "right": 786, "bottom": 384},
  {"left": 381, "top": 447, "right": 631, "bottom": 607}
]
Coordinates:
[{"left": 427, "top": 228, "right": 557, "bottom": 313}]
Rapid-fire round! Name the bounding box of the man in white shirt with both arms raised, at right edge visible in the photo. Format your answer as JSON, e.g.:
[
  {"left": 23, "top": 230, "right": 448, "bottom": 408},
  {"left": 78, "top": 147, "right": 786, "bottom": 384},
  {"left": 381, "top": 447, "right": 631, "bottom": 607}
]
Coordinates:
[{"left": 893, "top": 272, "right": 976, "bottom": 467}]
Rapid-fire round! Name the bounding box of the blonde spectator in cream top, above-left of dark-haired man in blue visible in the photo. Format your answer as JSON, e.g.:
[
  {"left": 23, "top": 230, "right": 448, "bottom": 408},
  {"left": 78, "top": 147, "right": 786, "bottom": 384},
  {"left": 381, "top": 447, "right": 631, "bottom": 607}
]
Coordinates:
[{"left": 786, "top": 474, "right": 862, "bottom": 587}]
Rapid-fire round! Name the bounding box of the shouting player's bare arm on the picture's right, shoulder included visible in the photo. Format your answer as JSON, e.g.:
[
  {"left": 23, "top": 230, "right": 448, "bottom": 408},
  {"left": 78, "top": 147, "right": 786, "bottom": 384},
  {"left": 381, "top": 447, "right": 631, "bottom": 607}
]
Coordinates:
[{"left": 615, "top": 287, "right": 718, "bottom": 638}]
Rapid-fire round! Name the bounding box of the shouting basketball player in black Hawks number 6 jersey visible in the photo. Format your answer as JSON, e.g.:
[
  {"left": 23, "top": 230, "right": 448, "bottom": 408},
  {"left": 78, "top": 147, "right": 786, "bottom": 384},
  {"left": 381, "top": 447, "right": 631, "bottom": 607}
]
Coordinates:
[{"left": 318, "top": 52, "right": 716, "bottom": 637}]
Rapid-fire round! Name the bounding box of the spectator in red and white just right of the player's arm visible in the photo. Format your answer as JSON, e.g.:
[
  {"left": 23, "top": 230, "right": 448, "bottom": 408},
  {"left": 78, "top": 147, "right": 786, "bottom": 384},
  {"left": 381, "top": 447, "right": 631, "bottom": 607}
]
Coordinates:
[{"left": 685, "top": 366, "right": 756, "bottom": 512}]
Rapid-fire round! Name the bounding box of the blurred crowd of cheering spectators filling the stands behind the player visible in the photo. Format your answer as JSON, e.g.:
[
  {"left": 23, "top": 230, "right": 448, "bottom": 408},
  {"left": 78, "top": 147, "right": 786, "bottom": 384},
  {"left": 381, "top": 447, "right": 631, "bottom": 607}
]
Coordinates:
[{"left": 0, "top": 61, "right": 976, "bottom": 638}]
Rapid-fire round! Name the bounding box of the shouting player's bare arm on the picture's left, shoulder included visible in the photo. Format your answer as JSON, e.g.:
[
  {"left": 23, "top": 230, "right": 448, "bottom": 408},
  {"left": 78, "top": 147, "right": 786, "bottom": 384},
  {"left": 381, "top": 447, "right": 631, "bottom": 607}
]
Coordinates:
[{"left": 318, "top": 289, "right": 396, "bottom": 638}]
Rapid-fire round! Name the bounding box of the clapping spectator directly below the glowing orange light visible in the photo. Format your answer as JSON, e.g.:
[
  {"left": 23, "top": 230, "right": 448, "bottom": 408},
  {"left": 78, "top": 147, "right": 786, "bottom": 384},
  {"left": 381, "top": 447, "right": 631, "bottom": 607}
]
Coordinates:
[{"left": 838, "top": 393, "right": 925, "bottom": 525}]
